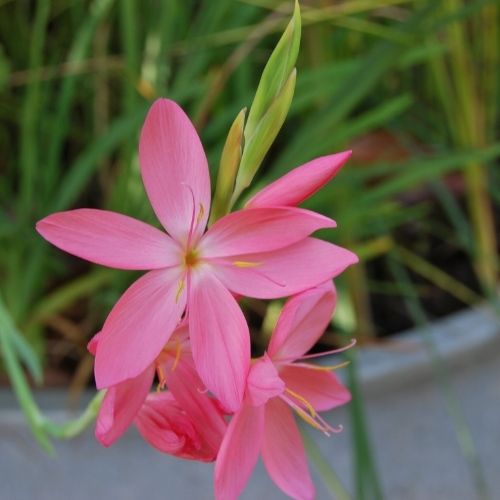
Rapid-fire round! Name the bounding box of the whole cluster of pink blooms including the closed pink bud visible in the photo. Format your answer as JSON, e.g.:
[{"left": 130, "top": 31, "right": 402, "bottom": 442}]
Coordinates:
[{"left": 37, "top": 99, "right": 357, "bottom": 499}]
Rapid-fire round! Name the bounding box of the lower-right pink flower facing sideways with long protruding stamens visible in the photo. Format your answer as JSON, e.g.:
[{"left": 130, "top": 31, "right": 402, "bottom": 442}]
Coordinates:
[{"left": 215, "top": 283, "right": 350, "bottom": 500}]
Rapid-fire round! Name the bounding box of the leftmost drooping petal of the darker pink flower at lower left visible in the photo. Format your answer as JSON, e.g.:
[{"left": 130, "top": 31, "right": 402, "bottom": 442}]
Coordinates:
[{"left": 95, "top": 365, "right": 154, "bottom": 446}]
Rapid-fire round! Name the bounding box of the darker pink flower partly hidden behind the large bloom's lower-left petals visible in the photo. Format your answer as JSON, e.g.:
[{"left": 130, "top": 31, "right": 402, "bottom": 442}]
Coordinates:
[{"left": 89, "top": 326, "right": 227, "bottom": 461}]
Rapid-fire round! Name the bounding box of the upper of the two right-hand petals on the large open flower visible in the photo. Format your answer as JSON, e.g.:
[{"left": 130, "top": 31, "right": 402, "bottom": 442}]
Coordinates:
[{"left": 198, "top": 208, "right": 335, "bottom": 258}]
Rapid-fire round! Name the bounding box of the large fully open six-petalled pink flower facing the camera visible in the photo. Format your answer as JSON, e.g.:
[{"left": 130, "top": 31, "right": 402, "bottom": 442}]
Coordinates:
[{"left": 37, "top": 99, "right": 357, "bottom": 411}]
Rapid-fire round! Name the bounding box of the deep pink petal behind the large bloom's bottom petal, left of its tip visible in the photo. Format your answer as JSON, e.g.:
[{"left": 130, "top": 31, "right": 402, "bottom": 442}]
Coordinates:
[{"left": 165, "top": 351, "right": 227, "bottom": 457}]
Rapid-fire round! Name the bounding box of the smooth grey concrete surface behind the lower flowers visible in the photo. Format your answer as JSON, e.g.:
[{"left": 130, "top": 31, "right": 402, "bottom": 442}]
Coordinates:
[{"left": 0, "top": 311, "right": 500, "bottom": 500}]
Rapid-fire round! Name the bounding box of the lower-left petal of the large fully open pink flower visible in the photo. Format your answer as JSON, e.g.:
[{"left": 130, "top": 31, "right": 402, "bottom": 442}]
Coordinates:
[{"left": 94, "top": 268, "right": 186, "bottom": 389}]
